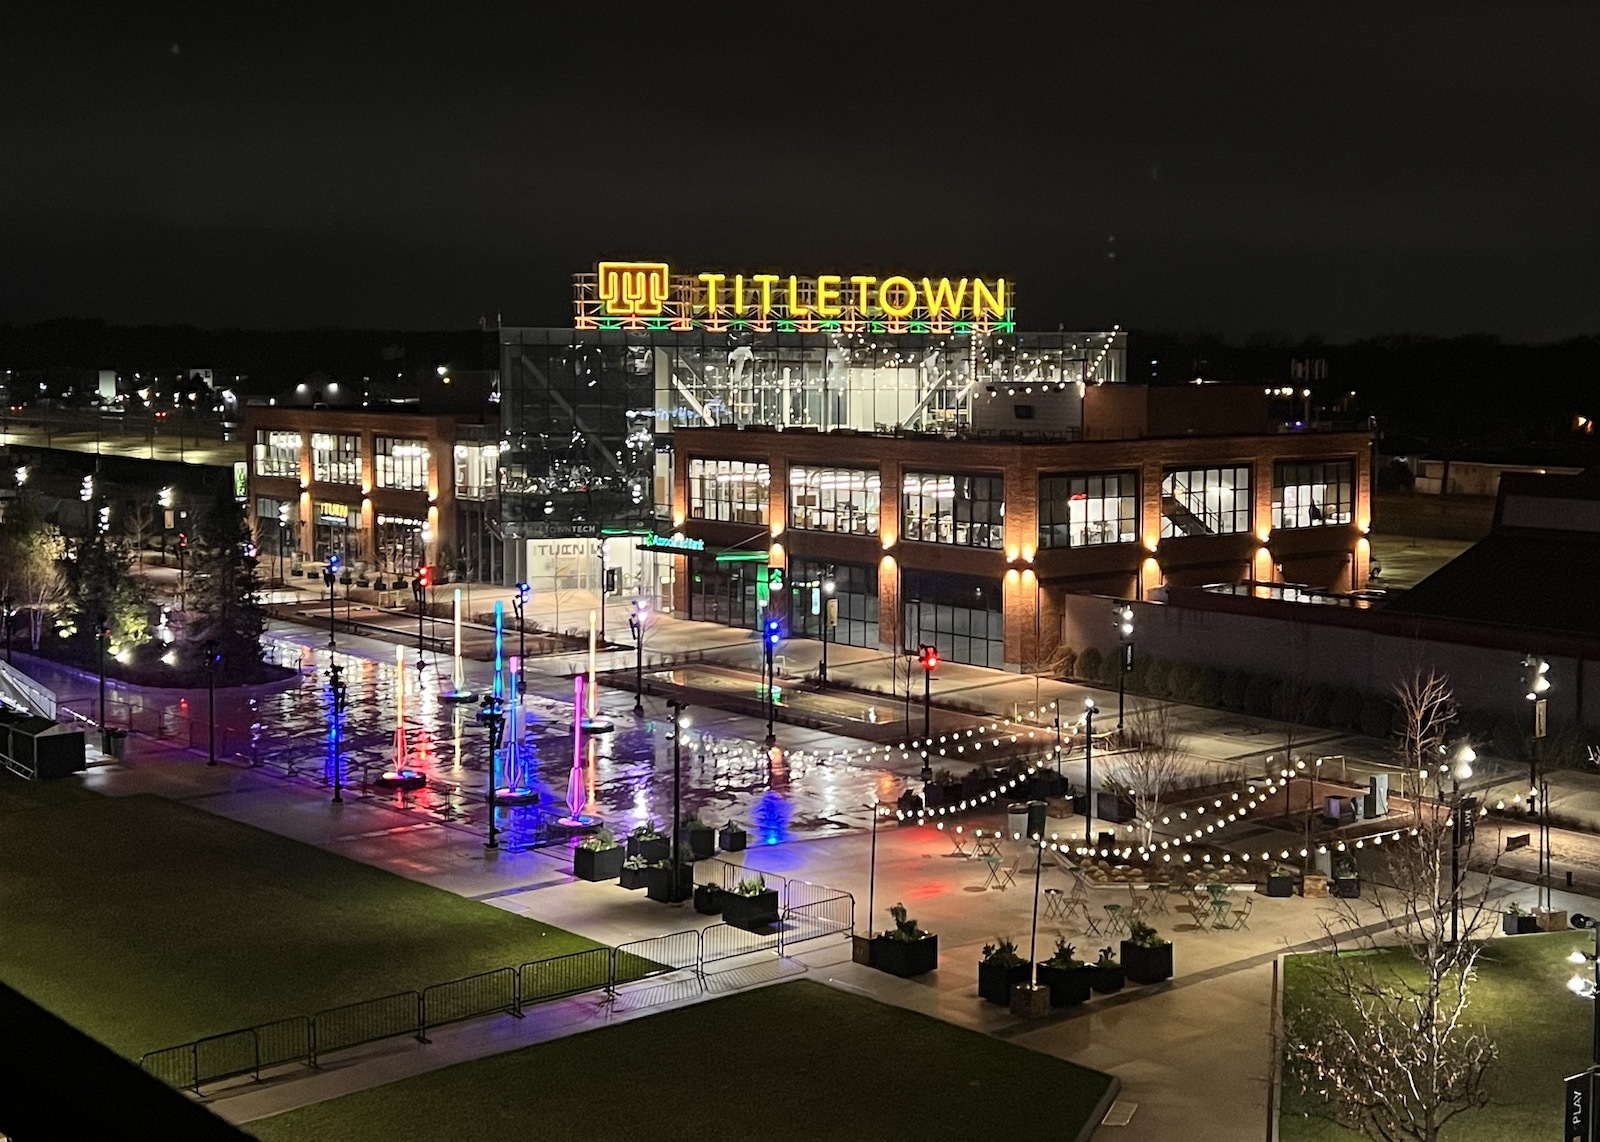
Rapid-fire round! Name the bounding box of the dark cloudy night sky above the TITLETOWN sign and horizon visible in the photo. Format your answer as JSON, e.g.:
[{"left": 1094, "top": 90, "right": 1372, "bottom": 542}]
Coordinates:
[{"left": 0, "top": 0, "right": 1600, "bottom": 341}]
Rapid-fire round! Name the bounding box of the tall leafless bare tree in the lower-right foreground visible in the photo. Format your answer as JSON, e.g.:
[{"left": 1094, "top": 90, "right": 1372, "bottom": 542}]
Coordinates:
[{"left": 1283, "top": 670, "right": 1496, "bottom": 1142}]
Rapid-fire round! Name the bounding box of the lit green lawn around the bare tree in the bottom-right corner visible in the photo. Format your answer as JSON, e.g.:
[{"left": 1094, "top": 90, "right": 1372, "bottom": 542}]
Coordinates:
[{"left": 1278, "top": 931, "right": 1594, "bottom": 1142}]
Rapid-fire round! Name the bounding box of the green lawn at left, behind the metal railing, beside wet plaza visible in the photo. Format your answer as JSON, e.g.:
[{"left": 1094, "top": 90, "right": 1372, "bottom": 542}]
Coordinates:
[{"left": 0, "top": 774, "right": 597, "bottom": 1059}]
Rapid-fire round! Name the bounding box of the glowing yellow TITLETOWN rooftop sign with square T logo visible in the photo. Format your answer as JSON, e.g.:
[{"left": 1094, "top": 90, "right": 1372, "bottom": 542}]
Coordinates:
[{"left": 574, "top": 262, "right": 1014, "bottom": 333}]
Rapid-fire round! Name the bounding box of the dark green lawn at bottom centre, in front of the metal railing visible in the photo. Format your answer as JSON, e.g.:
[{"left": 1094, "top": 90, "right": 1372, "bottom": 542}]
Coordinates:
[{"left": 245, "top": 980, "right": 1110, "bottom": 1142}]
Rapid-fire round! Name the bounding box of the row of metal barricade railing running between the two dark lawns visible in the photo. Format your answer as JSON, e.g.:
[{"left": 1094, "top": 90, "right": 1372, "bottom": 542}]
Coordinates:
[{"left": 139, "top": 865, "right": 856, "bottom": 1092}]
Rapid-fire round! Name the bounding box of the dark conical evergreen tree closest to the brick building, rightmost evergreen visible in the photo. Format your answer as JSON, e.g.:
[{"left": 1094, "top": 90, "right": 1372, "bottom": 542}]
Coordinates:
[{"left": 184, "top": 489, "right": 267, "bottom": 670}]
